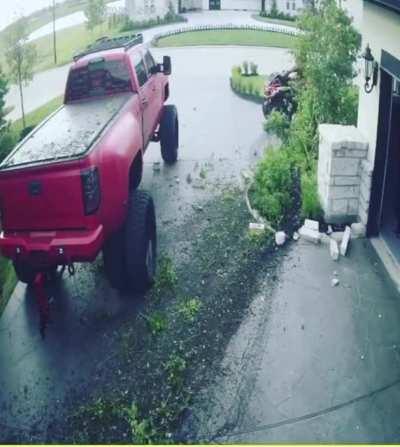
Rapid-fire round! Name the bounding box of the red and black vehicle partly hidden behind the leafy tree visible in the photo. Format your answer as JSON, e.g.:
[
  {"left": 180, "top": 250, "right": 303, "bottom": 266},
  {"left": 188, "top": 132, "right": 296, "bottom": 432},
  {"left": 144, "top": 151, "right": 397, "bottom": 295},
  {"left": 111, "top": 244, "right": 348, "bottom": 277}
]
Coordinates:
[{"left": 262, "top": 69, "right": 297, "bottom": 119}]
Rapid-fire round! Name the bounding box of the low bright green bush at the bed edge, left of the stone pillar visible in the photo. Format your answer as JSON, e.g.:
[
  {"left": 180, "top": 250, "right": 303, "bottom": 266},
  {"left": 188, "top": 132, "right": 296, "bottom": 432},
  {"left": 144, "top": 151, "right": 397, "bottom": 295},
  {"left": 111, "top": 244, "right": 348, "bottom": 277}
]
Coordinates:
[{"left": 250, "top": 148, "right": 294, "bottom": 225}]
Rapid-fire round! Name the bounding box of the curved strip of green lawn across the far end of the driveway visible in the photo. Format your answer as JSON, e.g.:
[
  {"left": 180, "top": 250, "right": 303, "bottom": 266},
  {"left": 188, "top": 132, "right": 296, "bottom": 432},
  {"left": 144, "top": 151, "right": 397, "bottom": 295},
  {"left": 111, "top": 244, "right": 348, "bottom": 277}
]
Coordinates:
[{"left": 153, "top": 30, "right": 296, "bottom": 48}]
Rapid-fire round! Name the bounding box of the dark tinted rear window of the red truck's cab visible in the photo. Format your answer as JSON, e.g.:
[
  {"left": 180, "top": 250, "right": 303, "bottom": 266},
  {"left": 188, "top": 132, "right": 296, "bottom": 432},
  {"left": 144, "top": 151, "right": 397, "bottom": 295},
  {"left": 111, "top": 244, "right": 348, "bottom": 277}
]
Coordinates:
[{"left": 66, "top": 59, "right": 132, "bottom": 102}]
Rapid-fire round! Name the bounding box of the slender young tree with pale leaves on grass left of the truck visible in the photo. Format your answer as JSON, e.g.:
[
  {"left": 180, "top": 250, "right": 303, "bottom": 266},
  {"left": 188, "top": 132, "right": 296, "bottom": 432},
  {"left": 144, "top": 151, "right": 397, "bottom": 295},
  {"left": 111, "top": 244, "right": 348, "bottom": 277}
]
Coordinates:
[{"left": 6, "top": 17, "right": 37, "bottom": 128}]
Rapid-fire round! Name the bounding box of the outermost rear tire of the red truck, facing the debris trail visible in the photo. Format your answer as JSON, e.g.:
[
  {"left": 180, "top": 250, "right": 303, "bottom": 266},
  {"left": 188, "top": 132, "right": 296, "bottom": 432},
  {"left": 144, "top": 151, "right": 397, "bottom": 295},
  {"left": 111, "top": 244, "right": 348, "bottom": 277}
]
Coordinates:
[{"left": 125, "top": 190, "right": 157, "bottom": 292}]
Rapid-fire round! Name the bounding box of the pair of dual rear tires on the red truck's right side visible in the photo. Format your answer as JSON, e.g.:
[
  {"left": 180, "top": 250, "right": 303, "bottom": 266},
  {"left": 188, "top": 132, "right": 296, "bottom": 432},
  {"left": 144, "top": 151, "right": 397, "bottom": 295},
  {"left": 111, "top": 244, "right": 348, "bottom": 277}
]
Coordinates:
[{"left": 103, "top": 190, "right": 157, "bottom": 292}]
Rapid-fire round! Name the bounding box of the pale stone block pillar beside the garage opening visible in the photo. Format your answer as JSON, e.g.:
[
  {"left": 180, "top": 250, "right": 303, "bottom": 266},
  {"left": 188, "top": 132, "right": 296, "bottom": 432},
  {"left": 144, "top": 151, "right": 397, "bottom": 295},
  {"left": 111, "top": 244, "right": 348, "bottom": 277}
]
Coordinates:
[{"left": 318, "top": 124, "right": 369, "bottom": 223}]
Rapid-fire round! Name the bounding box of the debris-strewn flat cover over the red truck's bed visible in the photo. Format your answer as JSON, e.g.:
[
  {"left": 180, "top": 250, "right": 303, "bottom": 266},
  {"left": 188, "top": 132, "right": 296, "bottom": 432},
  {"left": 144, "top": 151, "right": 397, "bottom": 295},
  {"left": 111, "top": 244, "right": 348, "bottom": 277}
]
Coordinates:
[{"left": 0, "top": 93, "right": 132, "bottom": 170}]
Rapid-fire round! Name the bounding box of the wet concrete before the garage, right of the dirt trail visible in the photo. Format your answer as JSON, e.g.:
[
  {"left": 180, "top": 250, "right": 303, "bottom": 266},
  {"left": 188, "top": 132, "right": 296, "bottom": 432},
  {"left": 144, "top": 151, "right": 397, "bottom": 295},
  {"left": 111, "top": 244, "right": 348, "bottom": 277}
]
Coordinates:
[{"left": 188, "top": 240, "right": 400, "bottom": 443}]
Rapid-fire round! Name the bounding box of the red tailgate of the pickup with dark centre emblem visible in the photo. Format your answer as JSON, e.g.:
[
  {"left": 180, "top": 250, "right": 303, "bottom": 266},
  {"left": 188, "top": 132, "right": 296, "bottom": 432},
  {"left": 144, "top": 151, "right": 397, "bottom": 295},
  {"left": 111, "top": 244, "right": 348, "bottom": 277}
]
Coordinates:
[{"left": 0, "top": 161, "right": 85, "bottom": 231}]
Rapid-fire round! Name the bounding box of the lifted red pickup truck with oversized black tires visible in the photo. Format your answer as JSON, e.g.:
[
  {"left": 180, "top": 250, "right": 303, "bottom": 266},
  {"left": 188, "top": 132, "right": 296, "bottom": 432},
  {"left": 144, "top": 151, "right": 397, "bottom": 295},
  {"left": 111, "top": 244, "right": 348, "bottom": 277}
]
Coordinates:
[{"left": 0, "top": 34, "right": 178, "bottom": 291}]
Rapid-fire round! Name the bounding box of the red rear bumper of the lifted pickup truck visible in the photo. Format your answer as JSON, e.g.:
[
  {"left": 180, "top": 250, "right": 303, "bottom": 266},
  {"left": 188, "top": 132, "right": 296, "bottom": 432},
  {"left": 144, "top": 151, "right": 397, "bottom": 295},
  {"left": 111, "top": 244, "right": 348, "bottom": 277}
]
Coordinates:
[{"left": 0, "top": 225, "right": 104, "bottom": 267}]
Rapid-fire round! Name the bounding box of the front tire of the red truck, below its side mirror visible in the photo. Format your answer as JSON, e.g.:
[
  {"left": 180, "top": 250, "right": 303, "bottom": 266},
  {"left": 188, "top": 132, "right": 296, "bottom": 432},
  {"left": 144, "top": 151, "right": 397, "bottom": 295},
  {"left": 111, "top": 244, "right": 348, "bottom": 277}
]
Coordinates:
[{"left": 159, "top": 105, "right": 179, "bottom": 164}]
